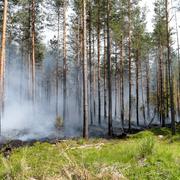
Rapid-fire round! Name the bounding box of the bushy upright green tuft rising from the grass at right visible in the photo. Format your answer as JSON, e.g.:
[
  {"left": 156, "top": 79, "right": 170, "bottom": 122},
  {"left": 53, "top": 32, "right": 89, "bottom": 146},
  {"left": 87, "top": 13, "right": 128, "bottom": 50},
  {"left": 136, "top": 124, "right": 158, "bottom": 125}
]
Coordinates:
[{"left": 138, "top": 136, "right": 155, "bottom": 158}]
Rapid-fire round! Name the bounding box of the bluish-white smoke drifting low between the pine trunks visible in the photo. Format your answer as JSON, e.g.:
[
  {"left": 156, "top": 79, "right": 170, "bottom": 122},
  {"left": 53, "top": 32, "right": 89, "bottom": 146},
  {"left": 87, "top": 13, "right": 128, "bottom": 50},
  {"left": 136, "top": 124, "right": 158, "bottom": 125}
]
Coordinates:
[{"left": 1, "top": 42, "right": 174, "bottom": 140}]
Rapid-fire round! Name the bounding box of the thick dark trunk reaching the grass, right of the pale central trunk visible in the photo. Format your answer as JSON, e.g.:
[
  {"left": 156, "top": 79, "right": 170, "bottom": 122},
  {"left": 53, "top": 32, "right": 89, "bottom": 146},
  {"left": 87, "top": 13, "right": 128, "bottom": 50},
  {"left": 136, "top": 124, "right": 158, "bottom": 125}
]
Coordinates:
[{"left": 107, "top": 0, "right": 113, "bottom": 136}]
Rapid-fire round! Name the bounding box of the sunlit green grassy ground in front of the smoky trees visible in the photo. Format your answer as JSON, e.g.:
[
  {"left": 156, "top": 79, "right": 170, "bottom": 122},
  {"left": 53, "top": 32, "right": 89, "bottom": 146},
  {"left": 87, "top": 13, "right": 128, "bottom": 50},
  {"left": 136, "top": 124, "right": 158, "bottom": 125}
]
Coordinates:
[{"left": 0, "top": 127, "right": 180, "bottom": 180}]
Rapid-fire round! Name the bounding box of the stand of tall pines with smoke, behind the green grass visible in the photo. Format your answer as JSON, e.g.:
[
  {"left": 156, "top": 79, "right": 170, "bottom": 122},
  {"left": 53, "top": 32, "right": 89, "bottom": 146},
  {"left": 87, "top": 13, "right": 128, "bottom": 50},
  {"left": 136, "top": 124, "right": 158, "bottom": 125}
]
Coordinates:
[{"left": 0, "top": 0, "right": 180, "bottom": 139}]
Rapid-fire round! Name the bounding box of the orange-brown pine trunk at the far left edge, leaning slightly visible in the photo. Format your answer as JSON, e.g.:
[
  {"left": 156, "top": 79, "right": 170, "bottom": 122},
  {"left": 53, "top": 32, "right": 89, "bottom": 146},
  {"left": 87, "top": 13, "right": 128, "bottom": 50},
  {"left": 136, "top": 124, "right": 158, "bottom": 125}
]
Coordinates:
[{"left": 0, "top": 0, "right": 8, "bottom": 135}]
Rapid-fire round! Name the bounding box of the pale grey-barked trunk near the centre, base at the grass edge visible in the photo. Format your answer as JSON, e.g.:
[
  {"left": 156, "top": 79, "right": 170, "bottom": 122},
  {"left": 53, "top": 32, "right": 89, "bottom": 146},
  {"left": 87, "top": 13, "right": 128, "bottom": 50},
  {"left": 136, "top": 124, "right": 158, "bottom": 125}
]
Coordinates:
[{"left": 83, "top": 0, "right": 88, "bottom": 139}]
